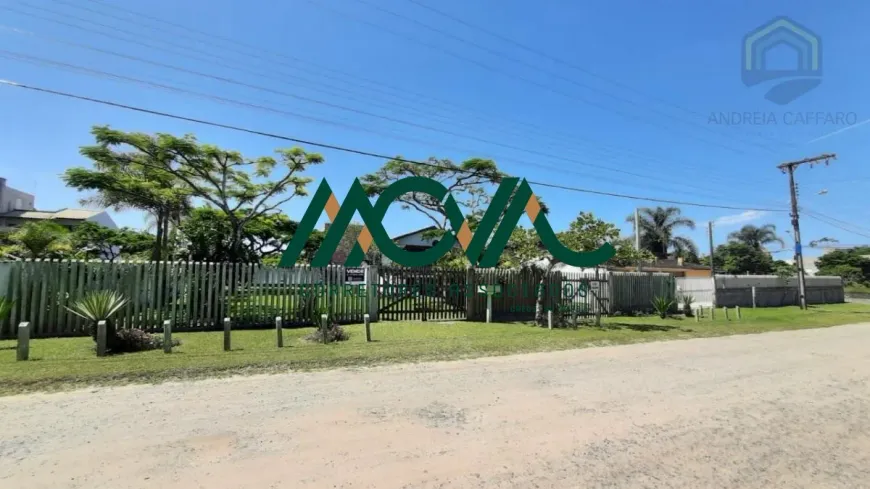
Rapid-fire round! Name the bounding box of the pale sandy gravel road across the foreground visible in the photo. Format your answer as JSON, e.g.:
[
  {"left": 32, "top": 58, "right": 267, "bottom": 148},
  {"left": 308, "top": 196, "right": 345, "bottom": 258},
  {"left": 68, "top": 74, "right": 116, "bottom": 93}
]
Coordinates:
[{"left": 0, "top": 324, "right": 870, "bottom": 489}]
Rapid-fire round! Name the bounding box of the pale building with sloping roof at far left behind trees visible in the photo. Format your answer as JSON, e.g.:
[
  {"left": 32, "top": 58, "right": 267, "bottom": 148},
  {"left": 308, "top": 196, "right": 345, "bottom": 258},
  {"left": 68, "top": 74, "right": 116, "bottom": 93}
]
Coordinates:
[{"left": 0, "top": 178, "right": 118, "bottom": 231}]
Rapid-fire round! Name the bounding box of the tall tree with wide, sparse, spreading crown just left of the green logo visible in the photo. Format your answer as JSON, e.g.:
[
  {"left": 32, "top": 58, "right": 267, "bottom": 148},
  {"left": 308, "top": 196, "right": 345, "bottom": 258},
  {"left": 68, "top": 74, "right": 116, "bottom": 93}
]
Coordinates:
[{"left": 78, "top": 126, "right": 324, "bottom": 261}]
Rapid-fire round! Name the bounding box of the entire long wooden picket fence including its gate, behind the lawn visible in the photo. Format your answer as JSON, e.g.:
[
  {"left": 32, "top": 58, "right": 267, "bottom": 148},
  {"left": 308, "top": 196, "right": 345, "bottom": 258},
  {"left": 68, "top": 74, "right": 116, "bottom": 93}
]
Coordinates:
[{"left": 0, "top": 260, "right": 675, "bottom": 338}]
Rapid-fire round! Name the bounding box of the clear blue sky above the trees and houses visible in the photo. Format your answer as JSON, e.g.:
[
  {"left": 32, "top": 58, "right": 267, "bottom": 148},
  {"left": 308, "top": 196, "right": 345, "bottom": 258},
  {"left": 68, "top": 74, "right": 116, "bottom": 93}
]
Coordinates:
[{"left": 0, "top": 0, "right": 870, "bottom": 258}]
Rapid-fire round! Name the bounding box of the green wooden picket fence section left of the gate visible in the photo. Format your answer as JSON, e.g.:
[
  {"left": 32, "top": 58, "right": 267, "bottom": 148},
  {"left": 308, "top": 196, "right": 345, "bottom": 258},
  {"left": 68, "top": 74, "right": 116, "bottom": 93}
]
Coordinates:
[{"left": 0, "top": 260, "right": 376, "bottom": 338}]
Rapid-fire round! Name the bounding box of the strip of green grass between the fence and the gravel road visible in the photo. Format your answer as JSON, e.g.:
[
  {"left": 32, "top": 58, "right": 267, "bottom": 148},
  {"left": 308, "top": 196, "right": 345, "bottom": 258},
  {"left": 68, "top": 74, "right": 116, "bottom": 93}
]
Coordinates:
[{"left": 0, "top": 304, "right": 870, "bottom": 395}]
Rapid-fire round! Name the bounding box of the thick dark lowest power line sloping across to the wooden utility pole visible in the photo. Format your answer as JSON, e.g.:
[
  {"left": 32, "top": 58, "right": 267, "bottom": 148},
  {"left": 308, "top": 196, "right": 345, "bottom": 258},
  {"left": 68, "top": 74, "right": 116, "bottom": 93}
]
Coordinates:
[{"left": 0, "top": 79, "right": 783, "bottom": 212}]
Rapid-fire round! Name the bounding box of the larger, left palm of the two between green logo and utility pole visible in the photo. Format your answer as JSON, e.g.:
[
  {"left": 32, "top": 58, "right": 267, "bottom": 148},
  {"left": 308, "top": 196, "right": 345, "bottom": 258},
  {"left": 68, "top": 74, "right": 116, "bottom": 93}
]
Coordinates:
[{"left": 625, "top": 207, "right": 698, "bottom": 258}]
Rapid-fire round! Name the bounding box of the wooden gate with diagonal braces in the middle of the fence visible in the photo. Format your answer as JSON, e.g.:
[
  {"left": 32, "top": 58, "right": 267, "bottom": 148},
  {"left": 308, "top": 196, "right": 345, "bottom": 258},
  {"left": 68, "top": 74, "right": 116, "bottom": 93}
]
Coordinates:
[{"left": 378, "top": 268, "right": 466, "bottom": 321}]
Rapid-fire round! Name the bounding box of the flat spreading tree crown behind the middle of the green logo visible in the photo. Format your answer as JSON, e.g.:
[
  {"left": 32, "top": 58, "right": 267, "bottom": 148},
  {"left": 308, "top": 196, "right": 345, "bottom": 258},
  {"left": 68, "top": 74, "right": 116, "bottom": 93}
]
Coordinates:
[{"left": 360, "top": 157, "right": 504, "bottom": 232}]
